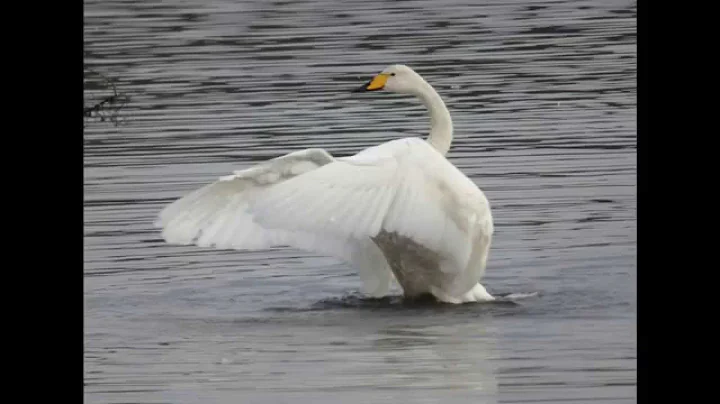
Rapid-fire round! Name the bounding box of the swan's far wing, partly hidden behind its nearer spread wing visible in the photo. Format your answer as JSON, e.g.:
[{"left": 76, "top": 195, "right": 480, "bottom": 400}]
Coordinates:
[{"left": 155, "top": 149, "right": 393, "bottom": 296}]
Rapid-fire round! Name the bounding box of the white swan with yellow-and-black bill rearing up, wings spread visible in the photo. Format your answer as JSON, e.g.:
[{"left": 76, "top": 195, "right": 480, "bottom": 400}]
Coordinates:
[{"left": 156, "top": 65, "right": 494, "bottom": 303}]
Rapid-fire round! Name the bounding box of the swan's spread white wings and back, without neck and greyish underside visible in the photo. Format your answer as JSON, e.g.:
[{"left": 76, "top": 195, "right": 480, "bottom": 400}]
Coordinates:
[{"left": 157, "top": 139, "right": 492, "bottom": 293}]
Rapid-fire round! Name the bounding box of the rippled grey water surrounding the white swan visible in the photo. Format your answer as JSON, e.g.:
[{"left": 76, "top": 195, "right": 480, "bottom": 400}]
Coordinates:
[{"left": 84, "top": 0, "right": 637, "bottom": 403}]
